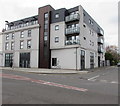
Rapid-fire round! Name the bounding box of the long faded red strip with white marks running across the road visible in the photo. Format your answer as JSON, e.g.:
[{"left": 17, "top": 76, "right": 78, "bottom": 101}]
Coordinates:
[{"left": 0, "top": 74, "right": 88, "bottom": 92}]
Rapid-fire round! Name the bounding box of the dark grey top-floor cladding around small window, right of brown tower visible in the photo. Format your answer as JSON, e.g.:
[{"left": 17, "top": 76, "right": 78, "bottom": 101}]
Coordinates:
[{"left": 51, "top": 8, "right": 66, "bottom": 23}]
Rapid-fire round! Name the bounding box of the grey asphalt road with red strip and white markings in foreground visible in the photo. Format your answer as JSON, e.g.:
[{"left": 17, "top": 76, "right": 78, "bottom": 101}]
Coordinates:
[{"left": 0, "top": 67, "right": 118, "bottom": 104}]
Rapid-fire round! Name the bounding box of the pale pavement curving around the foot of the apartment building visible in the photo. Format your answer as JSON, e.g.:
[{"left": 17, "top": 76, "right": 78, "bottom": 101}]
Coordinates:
[{"left": 0, "top": 67, "right": 112, "bottom": 74}]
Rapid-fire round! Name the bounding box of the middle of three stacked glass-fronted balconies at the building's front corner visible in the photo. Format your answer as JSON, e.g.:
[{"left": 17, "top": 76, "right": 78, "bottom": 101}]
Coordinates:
[{"left": 65, "top": 27, "right": 80, "bottom": 35}]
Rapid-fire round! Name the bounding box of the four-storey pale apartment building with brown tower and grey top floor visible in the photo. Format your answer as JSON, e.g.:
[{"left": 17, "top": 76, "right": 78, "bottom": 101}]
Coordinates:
[{"left": 3, "top": 5, "right": 105, "bottom": 70}]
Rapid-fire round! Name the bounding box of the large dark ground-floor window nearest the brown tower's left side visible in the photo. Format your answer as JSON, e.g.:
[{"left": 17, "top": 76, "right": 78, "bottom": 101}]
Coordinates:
[{"left": 19, "top": 53, "right": 30, "bottom": 68}]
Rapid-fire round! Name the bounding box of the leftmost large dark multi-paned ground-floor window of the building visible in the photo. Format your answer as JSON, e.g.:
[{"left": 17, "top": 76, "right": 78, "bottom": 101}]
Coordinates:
[{"left": 5, "top": 53, "right": 13, "bottom": 67}]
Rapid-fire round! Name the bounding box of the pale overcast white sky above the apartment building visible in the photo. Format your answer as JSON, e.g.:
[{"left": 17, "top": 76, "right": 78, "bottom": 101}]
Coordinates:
[{"left": 0, "top": 0, "right": 118, "bottom": 46}]
